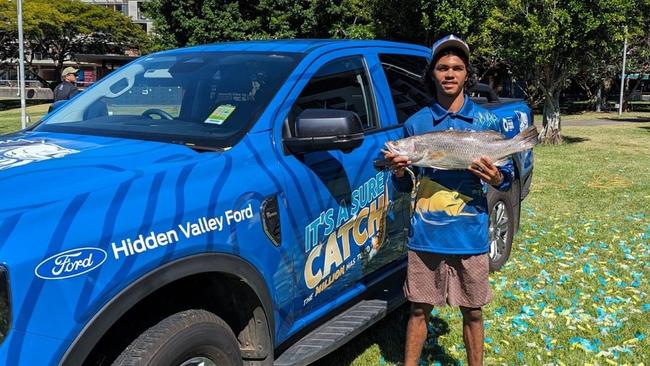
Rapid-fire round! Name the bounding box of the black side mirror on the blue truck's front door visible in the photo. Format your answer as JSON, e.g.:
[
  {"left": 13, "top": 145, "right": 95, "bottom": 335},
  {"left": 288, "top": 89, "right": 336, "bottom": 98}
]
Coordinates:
[{"left": 284, "top": 109, "right": 363, "bottom": 154}]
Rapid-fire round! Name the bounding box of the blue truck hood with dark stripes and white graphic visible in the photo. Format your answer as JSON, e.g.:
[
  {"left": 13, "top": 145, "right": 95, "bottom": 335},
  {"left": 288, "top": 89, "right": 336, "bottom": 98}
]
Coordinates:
[{"left": 0, "top": 132, "right": 198, "bottom": 218}]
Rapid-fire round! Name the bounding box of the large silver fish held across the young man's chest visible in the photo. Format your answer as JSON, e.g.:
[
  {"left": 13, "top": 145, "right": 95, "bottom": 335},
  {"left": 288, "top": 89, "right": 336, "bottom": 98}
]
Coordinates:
[{"left": 385, "top": 126, "right": 538, "bottom": 170}]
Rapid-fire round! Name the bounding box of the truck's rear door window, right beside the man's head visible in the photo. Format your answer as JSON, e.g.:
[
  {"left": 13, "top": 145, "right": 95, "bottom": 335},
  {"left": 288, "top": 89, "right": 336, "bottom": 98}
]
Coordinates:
[{"left": 379, "top": 54, "right": 431, "bottom": 123}]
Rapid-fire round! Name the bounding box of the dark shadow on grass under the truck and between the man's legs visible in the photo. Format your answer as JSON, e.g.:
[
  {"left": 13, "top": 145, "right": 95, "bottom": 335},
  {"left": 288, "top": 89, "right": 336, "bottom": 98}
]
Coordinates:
[{"left": 312, "top": 303, "right": 460, "bottom": 366}]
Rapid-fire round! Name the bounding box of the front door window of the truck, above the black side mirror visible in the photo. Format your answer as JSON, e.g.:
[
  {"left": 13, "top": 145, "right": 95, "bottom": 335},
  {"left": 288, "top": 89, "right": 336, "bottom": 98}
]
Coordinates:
[{"left": 291, "top": 56, "right": 377, "bottom": 130}]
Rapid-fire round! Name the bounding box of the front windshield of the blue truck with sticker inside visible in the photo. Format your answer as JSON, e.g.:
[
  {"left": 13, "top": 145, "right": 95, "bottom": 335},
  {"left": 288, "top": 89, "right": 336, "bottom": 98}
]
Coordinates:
[{"left": 35, "top": 52, "right": 300, "bottom": 148}]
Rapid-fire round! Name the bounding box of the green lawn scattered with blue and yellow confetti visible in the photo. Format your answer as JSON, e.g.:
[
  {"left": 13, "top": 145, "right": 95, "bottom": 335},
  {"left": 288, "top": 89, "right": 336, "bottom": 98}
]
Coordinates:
[{"left": 316, "top": 123, "right": 650, "bottom": 366}]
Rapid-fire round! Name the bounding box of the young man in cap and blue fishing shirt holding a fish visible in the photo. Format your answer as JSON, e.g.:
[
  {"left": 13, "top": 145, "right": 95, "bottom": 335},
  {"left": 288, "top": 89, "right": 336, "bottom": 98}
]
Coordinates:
[{"left": 385, "top": 35, "right": 514, "bottom": 366}]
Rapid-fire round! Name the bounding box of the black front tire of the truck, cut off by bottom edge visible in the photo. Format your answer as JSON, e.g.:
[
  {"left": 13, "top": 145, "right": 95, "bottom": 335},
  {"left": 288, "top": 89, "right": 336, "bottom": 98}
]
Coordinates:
[{"left": 113, "top": 310, "right": 242, "bottom": 366}]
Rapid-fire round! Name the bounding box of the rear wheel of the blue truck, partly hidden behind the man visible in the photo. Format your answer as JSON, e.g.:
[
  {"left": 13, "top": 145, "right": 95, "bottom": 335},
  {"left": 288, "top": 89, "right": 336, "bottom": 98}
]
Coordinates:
[{"left": 487, "top": 187, "right": 516, "bottom": 272}]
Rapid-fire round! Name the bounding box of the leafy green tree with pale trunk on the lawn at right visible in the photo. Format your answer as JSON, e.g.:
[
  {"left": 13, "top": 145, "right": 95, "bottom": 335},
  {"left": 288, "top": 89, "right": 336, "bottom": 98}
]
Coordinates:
[{"left": 487, "top": 0, "right": 647, "bottom": 144}]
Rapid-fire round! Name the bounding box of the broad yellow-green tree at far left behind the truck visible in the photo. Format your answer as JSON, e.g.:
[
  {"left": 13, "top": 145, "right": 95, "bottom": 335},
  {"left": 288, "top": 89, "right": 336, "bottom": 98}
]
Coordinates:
[{"left": 0, "top": 0, "right": 149, "bottom": 88}]
